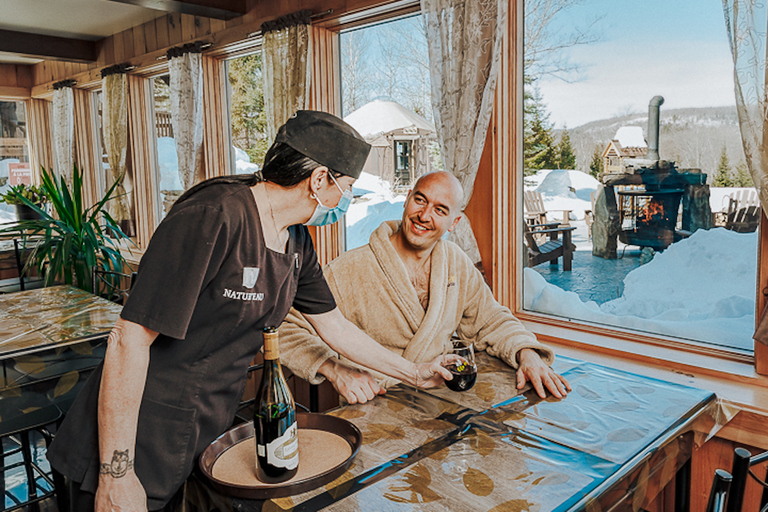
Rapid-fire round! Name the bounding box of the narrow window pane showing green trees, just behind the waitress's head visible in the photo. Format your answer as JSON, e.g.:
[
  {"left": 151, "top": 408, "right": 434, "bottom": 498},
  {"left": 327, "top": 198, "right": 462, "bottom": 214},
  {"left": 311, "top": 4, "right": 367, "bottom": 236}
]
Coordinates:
[{"left": 227, "top": 52, "right": 269, "bottom": 174}]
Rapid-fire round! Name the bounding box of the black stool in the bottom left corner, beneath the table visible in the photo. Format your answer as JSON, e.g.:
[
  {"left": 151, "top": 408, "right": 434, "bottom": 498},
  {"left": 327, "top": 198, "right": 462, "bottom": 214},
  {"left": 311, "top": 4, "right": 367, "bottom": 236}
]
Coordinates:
[{"left": 0, "top": 397, "right": 66, "bottom": 512}]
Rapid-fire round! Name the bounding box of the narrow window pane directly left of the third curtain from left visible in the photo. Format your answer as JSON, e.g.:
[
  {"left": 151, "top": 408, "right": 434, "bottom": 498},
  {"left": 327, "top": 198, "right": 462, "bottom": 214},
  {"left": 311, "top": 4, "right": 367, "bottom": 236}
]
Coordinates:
[{"left": 152, "top": 75, "right": 184, "bottom": 220}]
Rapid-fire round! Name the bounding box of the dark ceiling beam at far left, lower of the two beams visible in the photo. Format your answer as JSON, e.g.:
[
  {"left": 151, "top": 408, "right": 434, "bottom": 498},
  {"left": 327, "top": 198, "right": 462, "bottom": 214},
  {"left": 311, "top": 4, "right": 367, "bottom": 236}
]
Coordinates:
[{"left": 0, "top": 29, "right": 98, "bottom": 62}]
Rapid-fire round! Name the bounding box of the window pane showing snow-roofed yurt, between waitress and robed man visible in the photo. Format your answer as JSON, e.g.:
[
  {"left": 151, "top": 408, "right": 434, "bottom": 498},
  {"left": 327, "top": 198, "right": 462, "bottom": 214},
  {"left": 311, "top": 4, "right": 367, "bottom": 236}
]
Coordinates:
[{"left": 340, "top": 15, "right": 442, "bottom": 253}]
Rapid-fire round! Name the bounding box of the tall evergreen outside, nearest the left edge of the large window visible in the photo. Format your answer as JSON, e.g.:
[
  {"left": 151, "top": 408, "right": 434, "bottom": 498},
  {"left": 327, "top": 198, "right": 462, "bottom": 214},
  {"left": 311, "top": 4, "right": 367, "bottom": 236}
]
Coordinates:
[{"left": 523, "top": 84, "right": 558, "bottom": 172}]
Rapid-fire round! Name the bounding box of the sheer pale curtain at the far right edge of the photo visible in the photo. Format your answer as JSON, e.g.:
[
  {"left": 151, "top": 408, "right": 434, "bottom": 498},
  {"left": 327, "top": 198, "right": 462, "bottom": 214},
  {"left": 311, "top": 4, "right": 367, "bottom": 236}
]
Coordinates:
[{"left": 723, "top": 0, "right": 768, "bottom": 344}]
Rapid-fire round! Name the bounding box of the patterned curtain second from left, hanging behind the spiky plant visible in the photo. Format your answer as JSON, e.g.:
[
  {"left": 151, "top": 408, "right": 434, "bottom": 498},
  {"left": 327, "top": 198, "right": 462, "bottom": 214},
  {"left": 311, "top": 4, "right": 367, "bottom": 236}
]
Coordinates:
[{"left": 101, "top": 68, "right": 135, "bottom": 236}]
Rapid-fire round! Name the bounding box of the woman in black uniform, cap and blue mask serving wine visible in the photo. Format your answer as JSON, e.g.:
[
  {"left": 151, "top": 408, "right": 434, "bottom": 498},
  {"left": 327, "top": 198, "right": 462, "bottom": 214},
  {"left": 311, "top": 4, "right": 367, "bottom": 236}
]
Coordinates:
[{"left": 48, "top": 111, "right": 460, "bottom": 512}]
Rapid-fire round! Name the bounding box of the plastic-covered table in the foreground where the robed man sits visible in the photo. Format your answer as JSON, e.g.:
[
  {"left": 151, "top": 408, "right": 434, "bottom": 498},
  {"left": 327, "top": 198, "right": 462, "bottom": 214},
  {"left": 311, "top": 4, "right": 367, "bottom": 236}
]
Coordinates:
[{"left": 184, "top": 353, "right": 718, "bottom": 512}]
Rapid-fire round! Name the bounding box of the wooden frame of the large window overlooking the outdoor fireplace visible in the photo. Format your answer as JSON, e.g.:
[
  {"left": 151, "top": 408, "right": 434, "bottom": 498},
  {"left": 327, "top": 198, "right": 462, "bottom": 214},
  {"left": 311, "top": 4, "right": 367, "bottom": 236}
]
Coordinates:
[{"left": 488, "top": 0, "right": 768, "bottom": 376}]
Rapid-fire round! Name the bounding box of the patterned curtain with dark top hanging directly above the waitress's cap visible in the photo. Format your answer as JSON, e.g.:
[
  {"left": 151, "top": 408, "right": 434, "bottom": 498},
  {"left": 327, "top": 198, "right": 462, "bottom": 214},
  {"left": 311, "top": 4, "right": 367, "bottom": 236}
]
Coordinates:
[{"left": 261, "top": 11, "right": 310, "bottom": 141}]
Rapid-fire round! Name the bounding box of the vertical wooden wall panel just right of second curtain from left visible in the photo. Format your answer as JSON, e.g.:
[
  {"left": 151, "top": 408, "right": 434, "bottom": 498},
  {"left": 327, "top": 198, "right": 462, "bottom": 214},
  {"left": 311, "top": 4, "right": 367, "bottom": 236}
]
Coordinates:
[{"left": 128, "top": 74, "right": 158, "bottom": 249}]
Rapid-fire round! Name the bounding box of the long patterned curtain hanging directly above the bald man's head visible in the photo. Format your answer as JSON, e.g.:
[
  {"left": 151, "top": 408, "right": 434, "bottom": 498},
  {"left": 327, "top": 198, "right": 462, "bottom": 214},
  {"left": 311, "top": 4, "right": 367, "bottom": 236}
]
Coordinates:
[{"left": 421, "top": 0, "right": 508, "bottom": 264}]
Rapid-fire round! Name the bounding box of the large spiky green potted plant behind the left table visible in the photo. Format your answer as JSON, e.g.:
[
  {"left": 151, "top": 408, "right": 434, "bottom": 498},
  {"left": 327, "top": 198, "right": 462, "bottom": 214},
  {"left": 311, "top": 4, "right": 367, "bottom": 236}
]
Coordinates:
[{"left": 0, "top": 165, "right": 130, "bottom": 291}]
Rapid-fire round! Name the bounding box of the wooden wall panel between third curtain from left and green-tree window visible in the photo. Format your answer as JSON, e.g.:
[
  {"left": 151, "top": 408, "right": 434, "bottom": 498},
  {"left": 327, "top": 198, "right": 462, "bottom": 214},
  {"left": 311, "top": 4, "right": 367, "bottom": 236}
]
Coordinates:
[{"left": 202, "top": 55, "right": 232, "bottom": 178}]
